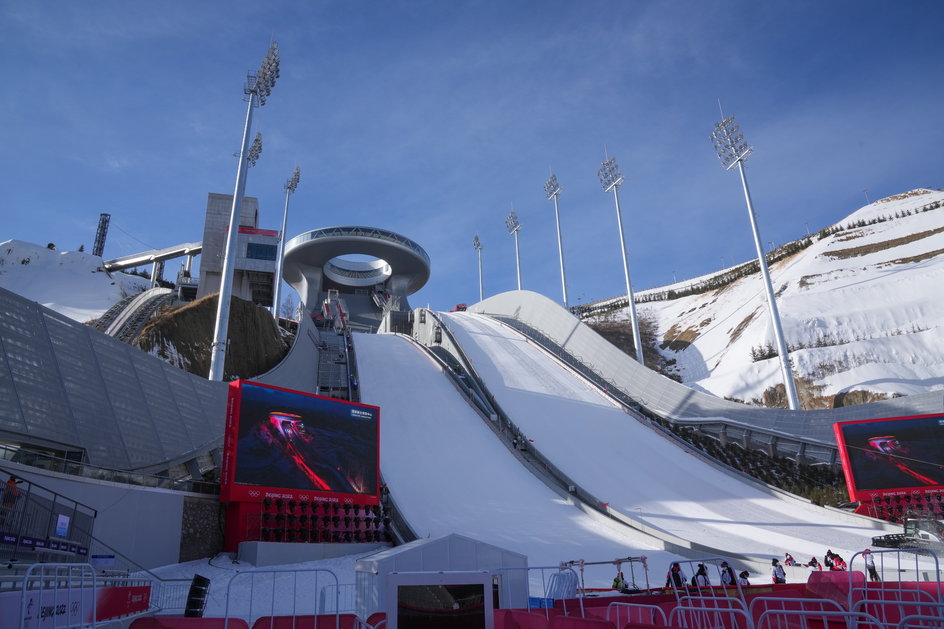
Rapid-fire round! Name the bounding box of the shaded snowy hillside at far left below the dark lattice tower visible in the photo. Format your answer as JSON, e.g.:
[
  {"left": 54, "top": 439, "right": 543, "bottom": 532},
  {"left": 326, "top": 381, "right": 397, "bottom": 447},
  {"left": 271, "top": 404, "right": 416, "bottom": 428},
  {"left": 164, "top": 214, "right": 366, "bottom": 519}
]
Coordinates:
[{"left": 0, "top": 240, "right": 151, "bottom": 323}]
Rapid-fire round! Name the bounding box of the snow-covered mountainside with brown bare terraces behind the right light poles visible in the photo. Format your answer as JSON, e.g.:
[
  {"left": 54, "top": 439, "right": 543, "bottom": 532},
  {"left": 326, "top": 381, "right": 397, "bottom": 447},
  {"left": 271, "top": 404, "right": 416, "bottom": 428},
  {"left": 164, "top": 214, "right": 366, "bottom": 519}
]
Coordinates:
[{"left": 591, "top": 189, "right": 944, "bottom": 405}]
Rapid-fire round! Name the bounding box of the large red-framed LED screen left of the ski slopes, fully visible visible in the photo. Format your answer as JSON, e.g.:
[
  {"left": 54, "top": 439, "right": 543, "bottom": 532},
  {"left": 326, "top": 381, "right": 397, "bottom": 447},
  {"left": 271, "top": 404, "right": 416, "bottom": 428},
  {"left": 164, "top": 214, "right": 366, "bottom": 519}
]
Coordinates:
[{"left": 220, "top": 381, "right": 380, "bottom": 504}]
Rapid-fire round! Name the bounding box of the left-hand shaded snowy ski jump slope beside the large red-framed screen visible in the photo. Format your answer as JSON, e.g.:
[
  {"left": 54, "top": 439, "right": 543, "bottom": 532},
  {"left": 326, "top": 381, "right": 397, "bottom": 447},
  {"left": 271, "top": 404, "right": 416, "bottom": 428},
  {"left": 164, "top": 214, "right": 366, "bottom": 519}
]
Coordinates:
[{"left": 354, "top": 334, "right": 680, "bottom": 587}]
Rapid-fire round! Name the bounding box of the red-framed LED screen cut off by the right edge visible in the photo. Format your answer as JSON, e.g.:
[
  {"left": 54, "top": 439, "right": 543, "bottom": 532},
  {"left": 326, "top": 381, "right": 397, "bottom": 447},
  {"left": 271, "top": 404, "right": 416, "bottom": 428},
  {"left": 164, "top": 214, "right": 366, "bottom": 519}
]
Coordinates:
[{"left": 834, "top": 415, "right": 944, "bottom": 500}]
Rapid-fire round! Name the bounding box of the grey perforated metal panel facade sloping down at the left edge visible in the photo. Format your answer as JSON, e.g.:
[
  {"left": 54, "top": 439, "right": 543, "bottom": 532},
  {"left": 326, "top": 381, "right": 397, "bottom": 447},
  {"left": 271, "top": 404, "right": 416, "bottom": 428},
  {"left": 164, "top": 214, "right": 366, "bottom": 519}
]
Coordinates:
[{"left": 0, "top": 289, "right": 226, "bottom": 469}]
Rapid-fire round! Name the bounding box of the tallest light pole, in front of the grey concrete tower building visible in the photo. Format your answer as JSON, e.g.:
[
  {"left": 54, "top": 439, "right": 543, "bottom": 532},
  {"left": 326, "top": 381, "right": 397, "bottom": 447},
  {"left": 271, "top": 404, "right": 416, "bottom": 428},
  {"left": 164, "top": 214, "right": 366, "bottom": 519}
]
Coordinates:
[{"left": 208, "top": 42, "right": 279, "bottom": 380}]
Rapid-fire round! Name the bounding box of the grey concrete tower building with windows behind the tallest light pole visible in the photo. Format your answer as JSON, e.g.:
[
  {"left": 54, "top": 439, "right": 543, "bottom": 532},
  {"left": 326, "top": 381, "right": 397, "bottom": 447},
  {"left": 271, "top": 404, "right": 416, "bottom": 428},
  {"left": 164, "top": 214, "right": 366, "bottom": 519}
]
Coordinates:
[{"left": 197, "top": 192, "right": 279, "bottom": 307}]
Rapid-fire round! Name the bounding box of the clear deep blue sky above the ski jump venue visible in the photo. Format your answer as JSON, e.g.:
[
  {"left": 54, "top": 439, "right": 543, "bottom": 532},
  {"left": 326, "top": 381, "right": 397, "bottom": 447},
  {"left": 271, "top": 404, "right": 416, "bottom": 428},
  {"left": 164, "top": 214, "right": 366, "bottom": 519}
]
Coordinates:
[{"left": 0, "top": 0, "right": 944, "bottom": 309}]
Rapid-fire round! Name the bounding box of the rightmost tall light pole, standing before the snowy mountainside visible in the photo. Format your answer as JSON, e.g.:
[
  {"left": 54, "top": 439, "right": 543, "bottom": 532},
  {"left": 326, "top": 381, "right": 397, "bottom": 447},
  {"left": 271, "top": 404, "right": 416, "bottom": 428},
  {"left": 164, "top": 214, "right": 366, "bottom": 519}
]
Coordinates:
[{"left": 711, "top": 111, "right": 800, "bottom": 410}]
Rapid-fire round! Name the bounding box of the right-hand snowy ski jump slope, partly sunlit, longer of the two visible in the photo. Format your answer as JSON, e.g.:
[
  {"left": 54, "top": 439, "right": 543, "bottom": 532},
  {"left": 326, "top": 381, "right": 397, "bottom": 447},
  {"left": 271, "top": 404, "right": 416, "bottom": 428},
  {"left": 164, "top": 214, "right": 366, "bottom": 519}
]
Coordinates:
[{"left": 443, "top": 313, "right": 890, "bottom": 561}]
